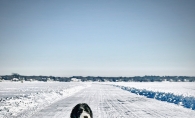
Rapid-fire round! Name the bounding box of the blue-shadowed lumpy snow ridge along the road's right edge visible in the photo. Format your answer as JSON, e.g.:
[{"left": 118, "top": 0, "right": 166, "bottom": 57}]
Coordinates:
[{"left": 113, "top": 85, "right": 195, "bottom": 110}]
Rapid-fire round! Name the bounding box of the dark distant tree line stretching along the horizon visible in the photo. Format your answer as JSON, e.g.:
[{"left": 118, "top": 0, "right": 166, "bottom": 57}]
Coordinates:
[{"left": 0, "top": 73, "right": 195, "bottom": 82}]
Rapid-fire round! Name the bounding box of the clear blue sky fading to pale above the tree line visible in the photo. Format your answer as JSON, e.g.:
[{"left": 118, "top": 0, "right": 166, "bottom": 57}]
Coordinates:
[{"left": 0, "top": 0, "right": 195, "bottom": 76}]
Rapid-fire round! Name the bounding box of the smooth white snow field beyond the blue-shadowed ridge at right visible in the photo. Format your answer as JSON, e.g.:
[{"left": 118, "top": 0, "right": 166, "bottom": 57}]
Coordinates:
[{"left": 108, "top": 82, "right": 195, "bottom": 97}]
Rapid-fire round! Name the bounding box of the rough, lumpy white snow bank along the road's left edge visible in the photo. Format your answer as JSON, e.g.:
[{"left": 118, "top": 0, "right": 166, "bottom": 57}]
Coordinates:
[{"left": 0, "top": 85, "right": 90, "bottom": 118}]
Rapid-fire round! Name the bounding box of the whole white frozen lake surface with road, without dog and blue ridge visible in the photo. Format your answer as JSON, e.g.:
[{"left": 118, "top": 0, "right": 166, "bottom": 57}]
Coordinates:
[{"left": 0, "top": 82, "right": 195, "bottom": 118}]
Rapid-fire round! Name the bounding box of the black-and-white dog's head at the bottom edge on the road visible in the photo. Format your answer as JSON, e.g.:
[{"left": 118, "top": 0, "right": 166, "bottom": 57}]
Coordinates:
[{"left": 70, "top": 103, "right": 93, "bottom": 118}]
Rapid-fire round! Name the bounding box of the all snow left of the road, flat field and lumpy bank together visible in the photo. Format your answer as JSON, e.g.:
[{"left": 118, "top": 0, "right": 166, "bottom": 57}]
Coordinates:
[{"left": 0, "top": 82, "right": 90, "bottom": 117}]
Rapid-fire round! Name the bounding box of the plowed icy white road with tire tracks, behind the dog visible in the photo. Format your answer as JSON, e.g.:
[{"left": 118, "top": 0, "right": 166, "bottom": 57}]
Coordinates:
[{"left": 30, "top": 84, "right": 195, "bottom": 118}]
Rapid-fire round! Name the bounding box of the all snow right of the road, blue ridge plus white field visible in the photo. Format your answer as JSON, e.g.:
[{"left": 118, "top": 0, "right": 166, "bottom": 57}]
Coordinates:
[{"left": 106, "top": 82, "right": 195, "bottom": 110}]
